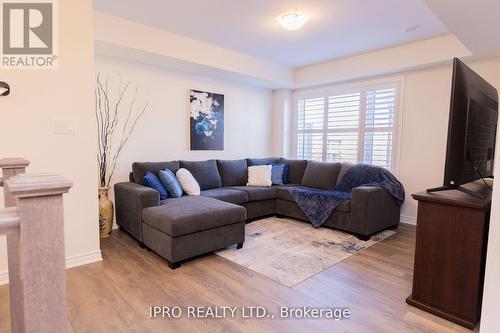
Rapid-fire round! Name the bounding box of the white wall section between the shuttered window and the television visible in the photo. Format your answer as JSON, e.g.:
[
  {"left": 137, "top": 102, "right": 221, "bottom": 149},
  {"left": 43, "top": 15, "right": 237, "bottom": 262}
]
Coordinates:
[{"left": 398, "top": 66, "right": 452, "bottom": 223}]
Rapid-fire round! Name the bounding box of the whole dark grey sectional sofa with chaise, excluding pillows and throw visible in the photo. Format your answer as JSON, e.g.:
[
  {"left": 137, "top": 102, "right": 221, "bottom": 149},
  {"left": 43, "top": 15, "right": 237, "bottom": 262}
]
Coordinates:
[{"left": 114, "top": 157, "right": 400, "bottom": 268}]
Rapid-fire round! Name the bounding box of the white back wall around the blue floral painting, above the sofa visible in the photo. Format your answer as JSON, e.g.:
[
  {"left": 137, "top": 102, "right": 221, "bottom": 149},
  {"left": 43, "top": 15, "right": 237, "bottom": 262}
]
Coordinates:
[{"left": 96, "top": 55, "right": 272, "bottom": 197}]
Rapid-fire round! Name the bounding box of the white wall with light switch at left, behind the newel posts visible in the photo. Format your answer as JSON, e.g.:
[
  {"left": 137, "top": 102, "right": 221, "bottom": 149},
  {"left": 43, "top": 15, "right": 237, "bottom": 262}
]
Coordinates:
[{"left": 0, "top": 0, "right": 101, "bottom": 283}]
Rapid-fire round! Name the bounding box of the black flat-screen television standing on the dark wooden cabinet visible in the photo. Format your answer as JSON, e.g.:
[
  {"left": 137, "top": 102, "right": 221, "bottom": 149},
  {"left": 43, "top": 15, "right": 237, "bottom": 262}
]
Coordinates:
[{"left": 427, "top": 58, "right": 498, "bottom": 198}]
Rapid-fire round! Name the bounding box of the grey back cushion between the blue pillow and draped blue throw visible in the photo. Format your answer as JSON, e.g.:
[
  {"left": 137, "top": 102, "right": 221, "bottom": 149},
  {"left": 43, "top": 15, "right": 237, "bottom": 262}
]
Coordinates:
[{"left": 301, "top": 161, "right": 341, "bottom": 190}]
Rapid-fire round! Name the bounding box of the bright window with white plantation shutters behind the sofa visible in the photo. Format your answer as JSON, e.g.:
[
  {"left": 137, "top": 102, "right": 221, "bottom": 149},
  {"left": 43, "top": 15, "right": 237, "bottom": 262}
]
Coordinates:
[{"left": 296, "top": 84, "right": 397, "bottom": 169}]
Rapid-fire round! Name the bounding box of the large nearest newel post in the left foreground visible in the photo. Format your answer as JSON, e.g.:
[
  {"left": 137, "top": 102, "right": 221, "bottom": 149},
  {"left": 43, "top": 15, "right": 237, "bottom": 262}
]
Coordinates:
[{"left": 4, "top": 173, "right": 72, "bottom": 332}]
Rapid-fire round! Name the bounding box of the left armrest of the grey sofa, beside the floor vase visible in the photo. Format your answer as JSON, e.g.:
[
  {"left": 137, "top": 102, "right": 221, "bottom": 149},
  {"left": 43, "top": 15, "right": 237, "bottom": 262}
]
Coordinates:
[{"left": 114, "top": 183, "right": 160, "bottom": 242}]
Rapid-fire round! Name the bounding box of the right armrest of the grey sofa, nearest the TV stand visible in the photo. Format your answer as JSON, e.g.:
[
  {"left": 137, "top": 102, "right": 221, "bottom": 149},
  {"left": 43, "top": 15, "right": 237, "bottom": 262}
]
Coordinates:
[{"left": 351, "top": 186, "right": 400, "bottom": 235}]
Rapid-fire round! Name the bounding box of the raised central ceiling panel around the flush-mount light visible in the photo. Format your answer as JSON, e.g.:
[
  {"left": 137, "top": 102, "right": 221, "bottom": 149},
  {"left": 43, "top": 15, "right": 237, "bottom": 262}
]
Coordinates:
[{"left": 93, "top": 0, "right": 448, "bottom": 67}]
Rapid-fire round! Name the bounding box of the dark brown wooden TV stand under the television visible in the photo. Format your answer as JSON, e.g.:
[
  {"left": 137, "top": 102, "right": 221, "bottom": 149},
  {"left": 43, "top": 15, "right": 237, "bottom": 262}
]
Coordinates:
[{"left": 406, "top": 179, "right": 493, "bottom": 329}]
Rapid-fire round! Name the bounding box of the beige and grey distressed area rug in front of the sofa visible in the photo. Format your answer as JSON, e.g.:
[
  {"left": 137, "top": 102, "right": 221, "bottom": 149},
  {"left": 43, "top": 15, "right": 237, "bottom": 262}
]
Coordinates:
[{"left": 217, "top": 217, "right": 396, "bottom": 287}]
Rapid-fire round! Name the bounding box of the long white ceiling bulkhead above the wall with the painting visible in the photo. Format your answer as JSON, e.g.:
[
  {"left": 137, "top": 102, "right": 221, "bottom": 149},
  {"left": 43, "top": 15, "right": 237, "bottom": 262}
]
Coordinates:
[{"left": 94, "top": 11, "right": 294, "bottom": 88}]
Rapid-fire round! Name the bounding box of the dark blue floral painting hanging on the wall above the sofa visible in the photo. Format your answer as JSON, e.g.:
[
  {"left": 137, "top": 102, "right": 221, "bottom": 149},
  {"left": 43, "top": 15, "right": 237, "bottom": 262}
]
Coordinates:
[{"left": 189, "top": 90, "right": 224, "bottom": 150}]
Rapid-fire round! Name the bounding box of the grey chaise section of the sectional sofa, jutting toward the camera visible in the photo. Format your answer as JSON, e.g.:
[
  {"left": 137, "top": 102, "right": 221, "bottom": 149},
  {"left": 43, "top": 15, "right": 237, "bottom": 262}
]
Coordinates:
[{"left": 142, "top": 196, "right": 246, "bottom": 268}]
